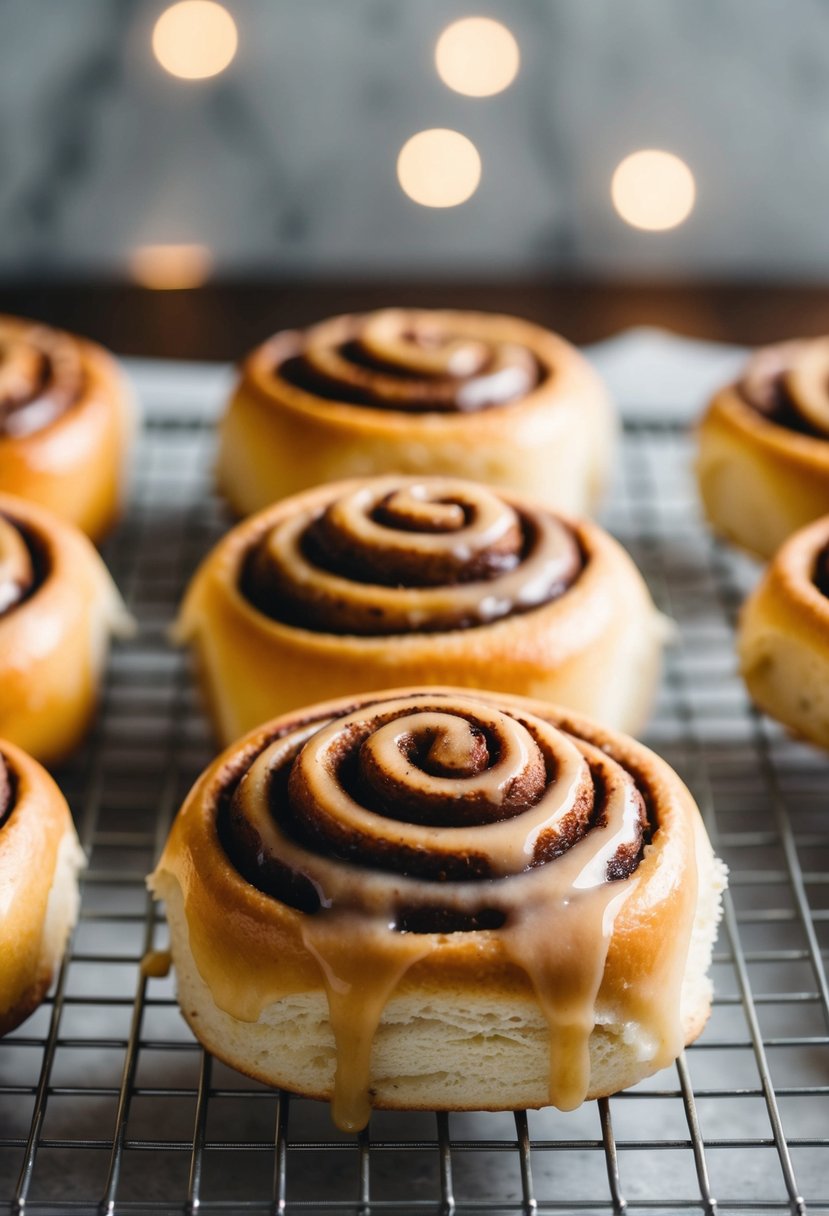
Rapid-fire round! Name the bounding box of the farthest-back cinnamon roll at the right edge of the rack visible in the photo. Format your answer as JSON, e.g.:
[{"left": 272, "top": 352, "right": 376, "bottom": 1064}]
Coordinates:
[{"left": 698, "top": 338, "right": 829, "bottom": 558}]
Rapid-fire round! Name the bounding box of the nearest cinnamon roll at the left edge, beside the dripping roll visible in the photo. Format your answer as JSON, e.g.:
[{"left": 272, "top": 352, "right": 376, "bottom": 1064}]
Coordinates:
[{"left": 0, "top": 742, "right": 84, "bottom": 1035}]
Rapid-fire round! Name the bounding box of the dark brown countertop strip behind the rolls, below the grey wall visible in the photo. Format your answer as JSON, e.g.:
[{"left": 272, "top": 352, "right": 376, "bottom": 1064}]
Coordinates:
[{"left": 0, "top": 280, "right": 829, "bottom": 360}]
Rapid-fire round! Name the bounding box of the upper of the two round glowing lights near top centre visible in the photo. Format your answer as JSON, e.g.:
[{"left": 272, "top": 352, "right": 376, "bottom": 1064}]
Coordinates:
[{"left": 435, "top": 17, "right": 521, "bottom": 97}]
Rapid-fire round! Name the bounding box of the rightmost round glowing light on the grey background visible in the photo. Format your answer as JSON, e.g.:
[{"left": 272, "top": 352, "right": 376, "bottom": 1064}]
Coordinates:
[{"left": 610, "top": 148, "right": 697, "bottom": 232}]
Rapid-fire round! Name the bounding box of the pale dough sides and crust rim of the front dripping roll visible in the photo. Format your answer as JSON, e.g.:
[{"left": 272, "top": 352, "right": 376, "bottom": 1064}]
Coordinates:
[{"left": 150, "top": 688, "right": 724, "bottom": 1110}]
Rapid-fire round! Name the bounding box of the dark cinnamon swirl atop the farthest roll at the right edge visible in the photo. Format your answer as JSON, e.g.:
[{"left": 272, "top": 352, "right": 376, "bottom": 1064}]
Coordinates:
[{"left": 739, "top": 338, "right": 829, "bottom": 439}]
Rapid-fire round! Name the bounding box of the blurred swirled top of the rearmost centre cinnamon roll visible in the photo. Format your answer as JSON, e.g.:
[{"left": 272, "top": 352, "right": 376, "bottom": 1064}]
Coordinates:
[{"left": 243, "top": 309, "right": 593, "bottom": 433}]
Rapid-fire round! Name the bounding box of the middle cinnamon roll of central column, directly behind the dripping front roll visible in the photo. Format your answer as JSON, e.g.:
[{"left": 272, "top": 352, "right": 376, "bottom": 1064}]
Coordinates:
[{"left": 176, "top": 475, "right": 665, "bottom": 742}]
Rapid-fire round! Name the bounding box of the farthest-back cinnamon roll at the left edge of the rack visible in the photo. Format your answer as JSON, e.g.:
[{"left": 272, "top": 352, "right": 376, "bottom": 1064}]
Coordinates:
[{"left": 0, "top": 316, "right": 132, "bottom": 540}]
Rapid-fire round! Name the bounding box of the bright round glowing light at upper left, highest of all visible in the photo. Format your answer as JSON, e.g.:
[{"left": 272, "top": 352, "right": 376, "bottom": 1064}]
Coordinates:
[{"left": 152, "top": 0, "right": 238, "bottom": 80}]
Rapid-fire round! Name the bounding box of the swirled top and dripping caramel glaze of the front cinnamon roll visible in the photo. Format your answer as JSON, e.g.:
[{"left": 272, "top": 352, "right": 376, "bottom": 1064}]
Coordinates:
[{"left": 151, "top": 689, "right": 698, "bottom": 1128}]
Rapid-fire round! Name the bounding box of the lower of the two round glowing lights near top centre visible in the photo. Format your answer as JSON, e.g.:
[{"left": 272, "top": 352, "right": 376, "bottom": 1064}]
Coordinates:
[{"left": 397, "top": 126, "right": 480, "bottom": 207}]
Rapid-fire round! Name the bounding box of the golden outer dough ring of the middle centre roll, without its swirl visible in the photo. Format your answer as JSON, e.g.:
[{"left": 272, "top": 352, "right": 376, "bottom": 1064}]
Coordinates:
[{"left": 176, "top": 478, "right": 667, "bottom": 743}]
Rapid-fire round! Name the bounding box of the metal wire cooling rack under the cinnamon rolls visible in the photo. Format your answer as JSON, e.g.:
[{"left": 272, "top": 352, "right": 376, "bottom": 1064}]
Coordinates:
[{"left": 0, "top": 401, "right": 829, "bottom": 1216}]
